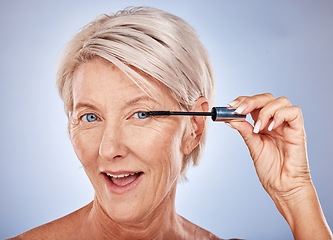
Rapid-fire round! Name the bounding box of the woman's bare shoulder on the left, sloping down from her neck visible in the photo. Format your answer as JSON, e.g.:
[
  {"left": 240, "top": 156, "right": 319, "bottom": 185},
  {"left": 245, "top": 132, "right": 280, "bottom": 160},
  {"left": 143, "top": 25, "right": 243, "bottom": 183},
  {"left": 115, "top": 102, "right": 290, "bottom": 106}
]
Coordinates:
[{"left": 8, "top": 204, "right": 91, "bottom": 240}]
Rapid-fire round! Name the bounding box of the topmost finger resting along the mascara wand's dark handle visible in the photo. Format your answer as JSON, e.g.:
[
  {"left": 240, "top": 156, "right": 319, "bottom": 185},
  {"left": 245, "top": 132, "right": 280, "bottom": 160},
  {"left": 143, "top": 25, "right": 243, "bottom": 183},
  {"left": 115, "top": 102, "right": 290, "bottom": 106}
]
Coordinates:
[{"left": 227, "top": 93, "right": 274, "bottom": 114}]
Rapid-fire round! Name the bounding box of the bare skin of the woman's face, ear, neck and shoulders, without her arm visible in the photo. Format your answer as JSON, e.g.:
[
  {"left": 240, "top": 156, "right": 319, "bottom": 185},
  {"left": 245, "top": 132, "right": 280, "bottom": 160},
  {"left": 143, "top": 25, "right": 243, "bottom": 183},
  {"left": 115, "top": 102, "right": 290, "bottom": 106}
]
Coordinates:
[{"left": 8, "top": 59, "right": 218, "bottom": 239}]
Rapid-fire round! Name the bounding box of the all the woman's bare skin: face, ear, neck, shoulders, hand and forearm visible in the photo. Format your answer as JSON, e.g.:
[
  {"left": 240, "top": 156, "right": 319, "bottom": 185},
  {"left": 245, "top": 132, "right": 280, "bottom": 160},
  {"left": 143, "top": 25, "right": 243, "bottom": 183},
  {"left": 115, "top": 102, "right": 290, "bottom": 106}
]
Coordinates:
[{"left": 9, "top": 59, "right": 332, "bottom": 240}]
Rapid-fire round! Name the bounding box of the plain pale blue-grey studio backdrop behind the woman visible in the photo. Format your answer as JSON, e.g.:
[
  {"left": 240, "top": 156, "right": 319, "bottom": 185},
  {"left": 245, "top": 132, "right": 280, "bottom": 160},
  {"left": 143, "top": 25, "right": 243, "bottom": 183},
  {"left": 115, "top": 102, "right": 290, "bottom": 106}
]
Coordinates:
[{"left": 0, "top": 0, "right": 333, "bottom": 239}]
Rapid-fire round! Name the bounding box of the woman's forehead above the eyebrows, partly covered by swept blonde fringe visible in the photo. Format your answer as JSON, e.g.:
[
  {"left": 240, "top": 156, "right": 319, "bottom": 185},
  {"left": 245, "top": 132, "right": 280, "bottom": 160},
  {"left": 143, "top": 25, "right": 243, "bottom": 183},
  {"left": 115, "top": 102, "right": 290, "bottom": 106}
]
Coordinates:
[{"left": 73, "top": 59, "right": 175, "bottom": 109}]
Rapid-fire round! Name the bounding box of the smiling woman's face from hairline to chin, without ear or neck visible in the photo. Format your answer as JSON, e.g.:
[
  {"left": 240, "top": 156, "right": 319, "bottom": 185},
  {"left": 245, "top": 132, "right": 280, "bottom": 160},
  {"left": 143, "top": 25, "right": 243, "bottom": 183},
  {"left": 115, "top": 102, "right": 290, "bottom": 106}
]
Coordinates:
[{"left": 70, "top": 59, "right": 186, "bottom": 222}]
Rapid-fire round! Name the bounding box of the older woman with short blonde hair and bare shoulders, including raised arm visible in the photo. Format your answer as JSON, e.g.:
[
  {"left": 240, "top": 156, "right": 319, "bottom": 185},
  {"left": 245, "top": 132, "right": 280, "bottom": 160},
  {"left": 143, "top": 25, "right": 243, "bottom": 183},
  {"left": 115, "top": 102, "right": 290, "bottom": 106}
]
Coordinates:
[{"left": 10, "top": 8, "right": 332, "bottom": 239}]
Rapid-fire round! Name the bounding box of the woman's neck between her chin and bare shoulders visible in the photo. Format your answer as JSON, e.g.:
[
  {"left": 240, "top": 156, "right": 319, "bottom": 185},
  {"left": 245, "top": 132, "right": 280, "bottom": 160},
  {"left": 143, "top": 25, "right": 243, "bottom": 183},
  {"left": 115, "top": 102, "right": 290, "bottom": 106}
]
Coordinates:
[{"left": 84, "top": 186, "right": 183, "bottom": 239}]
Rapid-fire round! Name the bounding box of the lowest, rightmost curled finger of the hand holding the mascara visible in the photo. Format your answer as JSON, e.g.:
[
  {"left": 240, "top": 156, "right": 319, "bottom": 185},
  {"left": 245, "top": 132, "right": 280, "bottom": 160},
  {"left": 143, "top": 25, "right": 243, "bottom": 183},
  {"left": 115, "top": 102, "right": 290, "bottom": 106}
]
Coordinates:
[{"left": 269, "top": 106, "right": 303, "bottom": 130}]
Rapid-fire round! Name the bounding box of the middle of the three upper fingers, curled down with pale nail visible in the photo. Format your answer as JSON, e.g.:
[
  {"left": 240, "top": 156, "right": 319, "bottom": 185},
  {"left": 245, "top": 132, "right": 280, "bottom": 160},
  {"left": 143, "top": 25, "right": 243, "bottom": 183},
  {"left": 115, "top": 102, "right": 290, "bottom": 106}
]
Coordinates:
[{"left": 254, "top": 97, "right": 291, "bottom": 133}]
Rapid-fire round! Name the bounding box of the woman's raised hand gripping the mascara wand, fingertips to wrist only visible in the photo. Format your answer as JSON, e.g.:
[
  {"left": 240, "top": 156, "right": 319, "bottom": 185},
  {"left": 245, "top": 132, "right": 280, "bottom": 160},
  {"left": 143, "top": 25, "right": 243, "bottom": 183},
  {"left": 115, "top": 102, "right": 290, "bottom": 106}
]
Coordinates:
[{"left": 230, "top": 94, "right": 311, "bottom": 200}]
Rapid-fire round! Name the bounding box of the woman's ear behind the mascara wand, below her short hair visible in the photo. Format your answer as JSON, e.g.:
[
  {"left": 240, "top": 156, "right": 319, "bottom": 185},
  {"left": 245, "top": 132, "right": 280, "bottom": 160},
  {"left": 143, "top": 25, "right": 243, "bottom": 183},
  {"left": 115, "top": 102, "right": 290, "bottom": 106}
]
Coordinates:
[{"left": 183, "top": 97, "right": 209, "bottom": 155}]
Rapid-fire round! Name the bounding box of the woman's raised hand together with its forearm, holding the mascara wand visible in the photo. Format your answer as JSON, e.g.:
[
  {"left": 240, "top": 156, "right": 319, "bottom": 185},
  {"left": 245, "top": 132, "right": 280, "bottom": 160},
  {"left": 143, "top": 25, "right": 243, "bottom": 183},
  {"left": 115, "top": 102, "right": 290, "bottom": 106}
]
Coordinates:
[{"left": 228, "top": 94, "right": 331, "bottom": 239}]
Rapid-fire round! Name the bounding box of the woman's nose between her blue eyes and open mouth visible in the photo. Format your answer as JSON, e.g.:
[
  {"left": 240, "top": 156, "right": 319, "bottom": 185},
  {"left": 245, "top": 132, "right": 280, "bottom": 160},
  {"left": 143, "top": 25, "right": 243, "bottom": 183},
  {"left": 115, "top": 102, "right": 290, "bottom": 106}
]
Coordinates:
[{"left": 99, "top": 124, "right": 128, "bottom": 161}]
